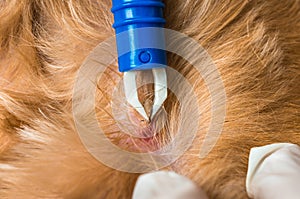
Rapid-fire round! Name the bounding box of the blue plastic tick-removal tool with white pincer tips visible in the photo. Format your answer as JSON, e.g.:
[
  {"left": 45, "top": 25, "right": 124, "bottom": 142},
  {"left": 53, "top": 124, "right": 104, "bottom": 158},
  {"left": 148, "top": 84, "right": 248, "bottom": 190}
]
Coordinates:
[{"left": 111, "top": 0, "right": 167, "bottom": 120}]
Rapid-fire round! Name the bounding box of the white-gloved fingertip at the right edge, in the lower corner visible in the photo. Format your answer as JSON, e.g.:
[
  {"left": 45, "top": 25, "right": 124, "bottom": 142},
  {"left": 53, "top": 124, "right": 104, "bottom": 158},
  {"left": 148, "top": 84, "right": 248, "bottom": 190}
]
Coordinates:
[{"left": 246, "top": 143, "right": 300, "bottom": 199}]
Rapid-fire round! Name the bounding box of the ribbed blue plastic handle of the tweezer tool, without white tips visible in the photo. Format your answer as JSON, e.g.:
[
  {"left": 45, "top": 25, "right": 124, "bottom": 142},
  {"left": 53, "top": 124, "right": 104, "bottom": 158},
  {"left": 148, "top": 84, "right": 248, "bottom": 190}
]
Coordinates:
[{"left": 111, "top": 0, "right": 167, "bottom": 72}]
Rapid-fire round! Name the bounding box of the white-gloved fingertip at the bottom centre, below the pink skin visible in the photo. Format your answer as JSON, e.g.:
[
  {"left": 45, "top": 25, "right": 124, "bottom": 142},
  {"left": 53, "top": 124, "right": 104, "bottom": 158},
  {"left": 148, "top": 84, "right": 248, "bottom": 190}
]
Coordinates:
[{"left": 132, "top": 171, "right": 208, "bottom": 199}]
